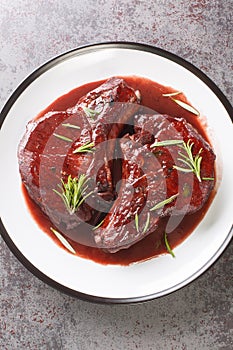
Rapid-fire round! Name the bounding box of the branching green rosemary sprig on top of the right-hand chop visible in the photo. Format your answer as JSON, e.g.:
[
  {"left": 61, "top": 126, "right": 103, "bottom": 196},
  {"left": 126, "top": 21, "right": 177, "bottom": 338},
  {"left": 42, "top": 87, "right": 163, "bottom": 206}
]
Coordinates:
[{"left": 173, "top": 140, "right": 202, "bottom": 182}]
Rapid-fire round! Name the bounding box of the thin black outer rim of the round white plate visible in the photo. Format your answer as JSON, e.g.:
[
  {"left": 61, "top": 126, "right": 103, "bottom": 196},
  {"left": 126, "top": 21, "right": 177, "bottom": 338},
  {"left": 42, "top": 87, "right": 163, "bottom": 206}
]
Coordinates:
[{"left": 0, "top": 41, "right": 233, "bottom": 304}]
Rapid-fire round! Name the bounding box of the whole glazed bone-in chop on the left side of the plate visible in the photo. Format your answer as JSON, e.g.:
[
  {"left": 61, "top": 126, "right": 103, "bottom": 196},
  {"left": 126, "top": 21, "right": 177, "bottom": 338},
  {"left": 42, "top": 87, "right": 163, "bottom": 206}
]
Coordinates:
[{"left": 18, "top": 78, "right": 139, "bottom": 228}]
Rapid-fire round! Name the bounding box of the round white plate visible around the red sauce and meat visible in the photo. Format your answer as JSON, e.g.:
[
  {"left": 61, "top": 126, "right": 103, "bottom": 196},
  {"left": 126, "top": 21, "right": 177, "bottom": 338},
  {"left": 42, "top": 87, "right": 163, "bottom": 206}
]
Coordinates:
[{"left": 0, "top": 43, "right": 233, "bottom": 303}]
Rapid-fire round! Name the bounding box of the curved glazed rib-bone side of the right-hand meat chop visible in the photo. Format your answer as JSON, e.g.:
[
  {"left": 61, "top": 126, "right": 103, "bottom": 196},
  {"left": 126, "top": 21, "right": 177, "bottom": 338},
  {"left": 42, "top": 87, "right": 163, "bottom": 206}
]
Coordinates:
[{"left": 94, "top": 137, "right": 162, "bottom": 253}]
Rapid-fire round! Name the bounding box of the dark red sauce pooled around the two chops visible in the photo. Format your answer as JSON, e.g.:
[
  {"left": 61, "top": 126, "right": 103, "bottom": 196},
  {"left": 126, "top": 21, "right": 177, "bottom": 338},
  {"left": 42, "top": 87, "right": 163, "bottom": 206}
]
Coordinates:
[{"left": 22, "top": 76, "right": 217, "bottom": 265}]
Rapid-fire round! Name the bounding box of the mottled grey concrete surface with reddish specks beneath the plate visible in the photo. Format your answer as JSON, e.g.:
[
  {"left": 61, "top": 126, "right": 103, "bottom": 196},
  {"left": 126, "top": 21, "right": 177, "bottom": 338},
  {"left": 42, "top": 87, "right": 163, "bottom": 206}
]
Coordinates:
[{"left": 0, "top": 0, "right": 233, "bottom": 350}]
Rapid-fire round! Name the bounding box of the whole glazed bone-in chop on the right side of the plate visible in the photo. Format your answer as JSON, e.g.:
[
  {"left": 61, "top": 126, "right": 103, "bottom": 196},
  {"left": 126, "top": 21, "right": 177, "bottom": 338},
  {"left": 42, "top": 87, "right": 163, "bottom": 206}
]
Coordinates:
[{"left": 94, "top": 115, "right": 215, "bottom": 253}]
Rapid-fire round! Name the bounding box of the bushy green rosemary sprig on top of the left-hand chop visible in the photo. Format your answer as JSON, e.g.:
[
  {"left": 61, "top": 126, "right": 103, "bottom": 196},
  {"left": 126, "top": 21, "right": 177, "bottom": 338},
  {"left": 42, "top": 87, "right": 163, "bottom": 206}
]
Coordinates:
[{"left": 53, "top": 174, "right": 93, "bottom": 214}]
